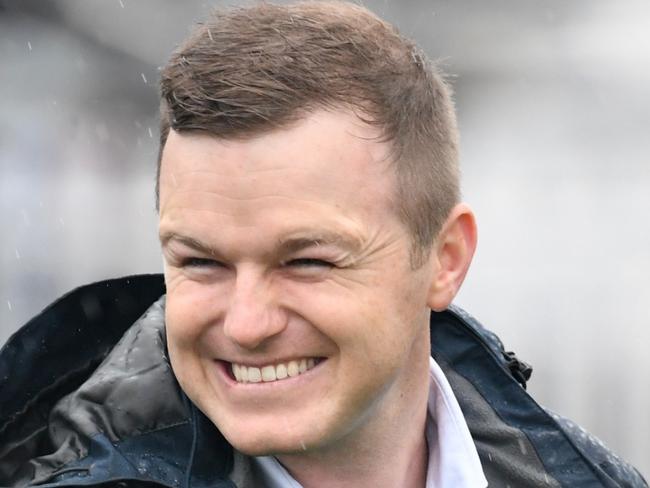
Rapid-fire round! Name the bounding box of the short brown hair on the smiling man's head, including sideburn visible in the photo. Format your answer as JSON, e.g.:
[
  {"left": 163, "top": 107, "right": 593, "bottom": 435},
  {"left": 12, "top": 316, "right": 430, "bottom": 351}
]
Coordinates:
[{"left": 156, "top": 1, "right": 459, "bottom": 261}]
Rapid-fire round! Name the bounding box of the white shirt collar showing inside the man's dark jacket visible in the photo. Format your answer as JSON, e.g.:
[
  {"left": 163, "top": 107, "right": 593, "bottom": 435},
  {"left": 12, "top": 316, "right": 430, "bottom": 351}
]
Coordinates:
[{"left": 252, "top": 358, "right": 487, "bottom": 488}]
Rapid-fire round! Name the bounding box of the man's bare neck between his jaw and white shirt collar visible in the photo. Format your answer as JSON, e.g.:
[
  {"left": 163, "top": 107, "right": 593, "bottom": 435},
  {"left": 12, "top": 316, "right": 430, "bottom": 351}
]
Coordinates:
[{"left": 278, "top": 331, "right": 429, "bottom": 488}]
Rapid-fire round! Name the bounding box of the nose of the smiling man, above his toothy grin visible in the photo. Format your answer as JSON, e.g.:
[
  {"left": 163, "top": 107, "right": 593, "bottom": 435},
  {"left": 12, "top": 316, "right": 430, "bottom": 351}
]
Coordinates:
[{"left": 223, "top": 270, "right": 287, "bottom": 350}]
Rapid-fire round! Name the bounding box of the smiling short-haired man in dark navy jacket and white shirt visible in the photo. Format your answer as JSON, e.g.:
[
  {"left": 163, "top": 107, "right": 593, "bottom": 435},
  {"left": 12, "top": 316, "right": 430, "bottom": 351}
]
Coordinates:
[{"left": 0, "top": 2, "right": 646, "bottom": 487}]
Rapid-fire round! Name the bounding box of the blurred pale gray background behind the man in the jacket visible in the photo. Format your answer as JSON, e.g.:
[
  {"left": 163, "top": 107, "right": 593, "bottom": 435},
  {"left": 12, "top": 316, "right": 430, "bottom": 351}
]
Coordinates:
[{"left": 0, "top": 0, "right": 650, "bottom": 476}]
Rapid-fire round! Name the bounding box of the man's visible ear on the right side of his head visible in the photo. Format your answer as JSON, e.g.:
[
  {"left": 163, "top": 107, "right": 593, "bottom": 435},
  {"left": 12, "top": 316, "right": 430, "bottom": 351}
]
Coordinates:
[{"left": 427, "top": 203, "right": 476, "bottom": 312}]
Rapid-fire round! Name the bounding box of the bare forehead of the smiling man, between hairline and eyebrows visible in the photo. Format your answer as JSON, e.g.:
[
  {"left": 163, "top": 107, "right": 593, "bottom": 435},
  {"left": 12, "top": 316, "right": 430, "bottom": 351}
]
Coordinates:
[{"left": 160, "top": 110, "right": 395, "bottom": 230}]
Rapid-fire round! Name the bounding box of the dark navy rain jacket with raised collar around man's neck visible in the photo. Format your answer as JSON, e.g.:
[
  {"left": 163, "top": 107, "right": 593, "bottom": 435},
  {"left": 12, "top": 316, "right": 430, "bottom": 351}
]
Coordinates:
[{"left": 0, "top": 275, "right": 648, "bottom": 488}]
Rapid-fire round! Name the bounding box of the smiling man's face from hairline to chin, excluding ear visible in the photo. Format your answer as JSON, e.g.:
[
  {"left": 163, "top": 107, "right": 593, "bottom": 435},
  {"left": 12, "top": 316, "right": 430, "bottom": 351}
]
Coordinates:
[{"left": 160, "top": 111, "right": 432, "bottom": 454}]
